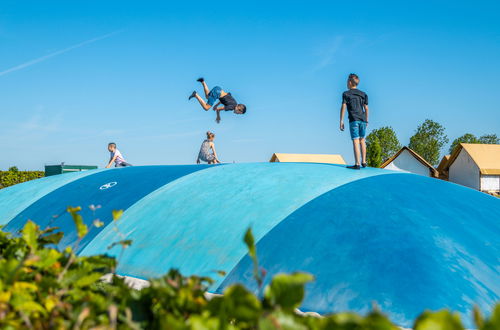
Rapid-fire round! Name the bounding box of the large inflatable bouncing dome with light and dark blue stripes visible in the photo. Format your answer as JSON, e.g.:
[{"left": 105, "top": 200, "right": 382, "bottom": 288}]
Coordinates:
[{"left": 0, "top": 163, "right": 500, "bottom": 326}]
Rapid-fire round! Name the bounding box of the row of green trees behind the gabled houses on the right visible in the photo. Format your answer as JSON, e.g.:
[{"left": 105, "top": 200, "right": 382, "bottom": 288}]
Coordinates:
[{"left": 366, "top": 119, "right": 500, "bottom": 167}]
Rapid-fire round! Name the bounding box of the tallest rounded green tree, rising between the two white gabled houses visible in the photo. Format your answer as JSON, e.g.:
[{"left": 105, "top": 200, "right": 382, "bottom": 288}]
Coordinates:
[{"left": 408, "top": 119, "right": 449, "bottom": 166}]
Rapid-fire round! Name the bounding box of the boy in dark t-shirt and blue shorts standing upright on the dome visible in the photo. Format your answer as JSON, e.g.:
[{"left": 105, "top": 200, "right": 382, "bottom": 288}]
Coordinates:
[{"left": 340, "top": 73, "right": 368, "bottom": 170}]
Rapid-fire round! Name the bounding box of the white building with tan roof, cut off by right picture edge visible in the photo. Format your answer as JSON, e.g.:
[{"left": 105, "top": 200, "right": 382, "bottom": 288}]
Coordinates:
[{"left": 441, "top": 143, "right": 500, "bottom": 193}]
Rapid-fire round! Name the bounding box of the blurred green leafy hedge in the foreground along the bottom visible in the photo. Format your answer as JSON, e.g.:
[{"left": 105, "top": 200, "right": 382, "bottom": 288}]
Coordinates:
[{"left": 0, "top": 208, "right": 500, "bottom": 330}]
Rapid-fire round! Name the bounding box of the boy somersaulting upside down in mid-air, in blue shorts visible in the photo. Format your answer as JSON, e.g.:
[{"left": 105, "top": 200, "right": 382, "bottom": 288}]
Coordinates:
[{"left": 189, "top": 78, "right": 247, "bottom": 123}]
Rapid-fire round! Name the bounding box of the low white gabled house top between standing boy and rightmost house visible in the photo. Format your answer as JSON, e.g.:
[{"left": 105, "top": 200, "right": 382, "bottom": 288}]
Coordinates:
[{"left": 380, "top": 147, "right": 438, "bottom": 178}]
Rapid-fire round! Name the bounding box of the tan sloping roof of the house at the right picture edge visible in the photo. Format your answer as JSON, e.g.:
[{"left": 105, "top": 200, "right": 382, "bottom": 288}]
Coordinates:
[{"left": 445, "top": 143, "right": 500, "bottom": 175}]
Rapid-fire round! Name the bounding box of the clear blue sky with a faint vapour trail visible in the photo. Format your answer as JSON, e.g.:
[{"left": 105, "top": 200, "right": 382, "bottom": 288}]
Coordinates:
[{"left": 0, "top": 0, "right": 500, "bottom": 169}]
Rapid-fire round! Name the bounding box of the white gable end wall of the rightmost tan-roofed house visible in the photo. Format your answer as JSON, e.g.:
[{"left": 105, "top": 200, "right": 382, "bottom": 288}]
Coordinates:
[{"left": 448, "top": 149, "right": 480, "bottom": 190}]
